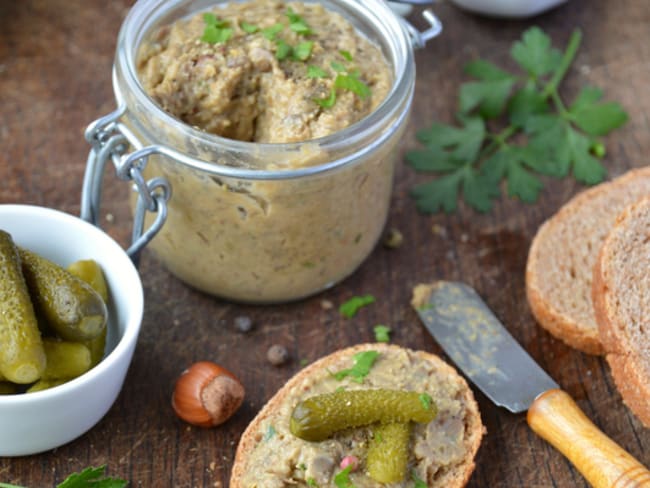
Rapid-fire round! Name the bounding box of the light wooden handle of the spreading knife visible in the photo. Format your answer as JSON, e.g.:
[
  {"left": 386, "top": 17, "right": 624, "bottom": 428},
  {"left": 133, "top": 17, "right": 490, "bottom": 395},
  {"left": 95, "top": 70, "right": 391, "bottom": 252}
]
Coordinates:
[{"left": 528, "top": 389, "right": 650, "bottom": 488}]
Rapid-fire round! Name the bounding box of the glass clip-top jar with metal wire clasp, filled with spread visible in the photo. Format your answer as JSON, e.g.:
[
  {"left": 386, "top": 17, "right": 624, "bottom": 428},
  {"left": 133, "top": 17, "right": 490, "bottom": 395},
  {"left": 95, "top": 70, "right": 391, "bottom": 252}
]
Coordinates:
[{"left": 82, "top": 0, "right": 440, "bottom": 303}]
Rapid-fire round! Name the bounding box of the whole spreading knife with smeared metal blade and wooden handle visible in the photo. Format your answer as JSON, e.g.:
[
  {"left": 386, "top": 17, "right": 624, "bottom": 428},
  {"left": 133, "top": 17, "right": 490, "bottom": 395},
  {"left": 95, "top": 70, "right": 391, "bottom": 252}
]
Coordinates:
[{"left": 411, "top": 281, "right": 650, "bottom": 488}]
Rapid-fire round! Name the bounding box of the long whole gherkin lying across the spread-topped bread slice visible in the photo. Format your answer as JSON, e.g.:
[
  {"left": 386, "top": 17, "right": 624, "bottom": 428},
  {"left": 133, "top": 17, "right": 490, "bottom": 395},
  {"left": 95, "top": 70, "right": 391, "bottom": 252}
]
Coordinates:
[{"left": 290, "top": 389, "right": 436, "bottom": 441}]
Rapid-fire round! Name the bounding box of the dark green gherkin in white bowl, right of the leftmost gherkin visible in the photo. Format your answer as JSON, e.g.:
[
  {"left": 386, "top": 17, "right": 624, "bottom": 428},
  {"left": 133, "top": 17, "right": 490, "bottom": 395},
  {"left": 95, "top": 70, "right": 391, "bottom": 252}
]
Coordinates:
[{"left": 19, "top": 249, "right": 107, "bottom": 341}]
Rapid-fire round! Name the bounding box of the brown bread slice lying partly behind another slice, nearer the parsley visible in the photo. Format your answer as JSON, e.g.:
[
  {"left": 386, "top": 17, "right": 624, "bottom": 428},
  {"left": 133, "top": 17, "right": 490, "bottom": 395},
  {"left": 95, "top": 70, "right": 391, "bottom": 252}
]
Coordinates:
[{"left": 526, "top": 166, "right": 650, "bottom": 354}]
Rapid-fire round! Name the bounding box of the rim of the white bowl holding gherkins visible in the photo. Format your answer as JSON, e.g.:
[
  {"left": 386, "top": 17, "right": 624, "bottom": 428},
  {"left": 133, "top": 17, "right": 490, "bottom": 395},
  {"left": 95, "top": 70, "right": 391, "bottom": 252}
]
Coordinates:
[{"left": 0, "top": 204, "right": 144, "bottom": 406}]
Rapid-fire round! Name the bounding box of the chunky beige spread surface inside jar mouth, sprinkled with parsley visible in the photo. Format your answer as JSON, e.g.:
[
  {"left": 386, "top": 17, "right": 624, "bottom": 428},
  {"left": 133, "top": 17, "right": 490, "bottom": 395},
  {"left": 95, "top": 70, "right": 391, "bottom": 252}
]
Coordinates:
[{"left": 138, "top": 1, "right": 392, "bottom": 143}]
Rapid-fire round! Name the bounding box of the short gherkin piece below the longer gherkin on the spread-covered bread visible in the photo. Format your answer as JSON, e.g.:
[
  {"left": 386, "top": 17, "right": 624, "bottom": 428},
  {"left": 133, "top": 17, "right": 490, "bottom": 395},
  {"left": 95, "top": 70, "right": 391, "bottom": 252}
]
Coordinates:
[{"left": 366, "top": 422, "right": 411, "bottom": 483}]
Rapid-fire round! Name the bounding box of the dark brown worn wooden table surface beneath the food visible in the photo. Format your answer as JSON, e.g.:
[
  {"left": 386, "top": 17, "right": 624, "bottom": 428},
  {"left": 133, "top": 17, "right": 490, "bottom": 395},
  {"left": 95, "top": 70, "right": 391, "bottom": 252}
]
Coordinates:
[{"left": 0, "top": 0, "right": 650, "bottom": 488}]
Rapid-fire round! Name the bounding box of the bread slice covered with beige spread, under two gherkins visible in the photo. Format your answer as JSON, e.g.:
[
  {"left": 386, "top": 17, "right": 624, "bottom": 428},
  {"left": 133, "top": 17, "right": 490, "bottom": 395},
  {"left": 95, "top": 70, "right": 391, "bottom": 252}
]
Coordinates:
[{"left": 230, "top": 343, "right": 485, "bottom": 488}]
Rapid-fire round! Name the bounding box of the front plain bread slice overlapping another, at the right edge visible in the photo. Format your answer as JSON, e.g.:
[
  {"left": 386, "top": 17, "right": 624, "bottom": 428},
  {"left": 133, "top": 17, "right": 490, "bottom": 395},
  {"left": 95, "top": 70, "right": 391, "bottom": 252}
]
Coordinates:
[{"left": 592, "top": 196, "right": 650, "bottom": 427}]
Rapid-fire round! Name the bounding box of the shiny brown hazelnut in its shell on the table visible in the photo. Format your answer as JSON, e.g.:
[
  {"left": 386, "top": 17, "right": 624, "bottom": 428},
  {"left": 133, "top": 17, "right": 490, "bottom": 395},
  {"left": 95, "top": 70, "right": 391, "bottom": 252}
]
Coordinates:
[{"left": 172, "top": 361, "right": 245, "bottom": 427}]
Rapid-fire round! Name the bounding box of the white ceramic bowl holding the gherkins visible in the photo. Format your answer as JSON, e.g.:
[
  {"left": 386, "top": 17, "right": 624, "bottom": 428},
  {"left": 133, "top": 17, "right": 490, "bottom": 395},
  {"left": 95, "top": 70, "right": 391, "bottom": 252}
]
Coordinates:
[{"left": 0, "top": 205, "right": 143, "bottom": 456}]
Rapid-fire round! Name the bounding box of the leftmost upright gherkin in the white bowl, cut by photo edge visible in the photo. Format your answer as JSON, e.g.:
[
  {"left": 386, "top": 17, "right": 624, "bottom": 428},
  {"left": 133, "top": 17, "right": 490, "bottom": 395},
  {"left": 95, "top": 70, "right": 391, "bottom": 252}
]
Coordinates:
[{"left": 0, "top": 231, "right": 45, "bottom": 383}]
